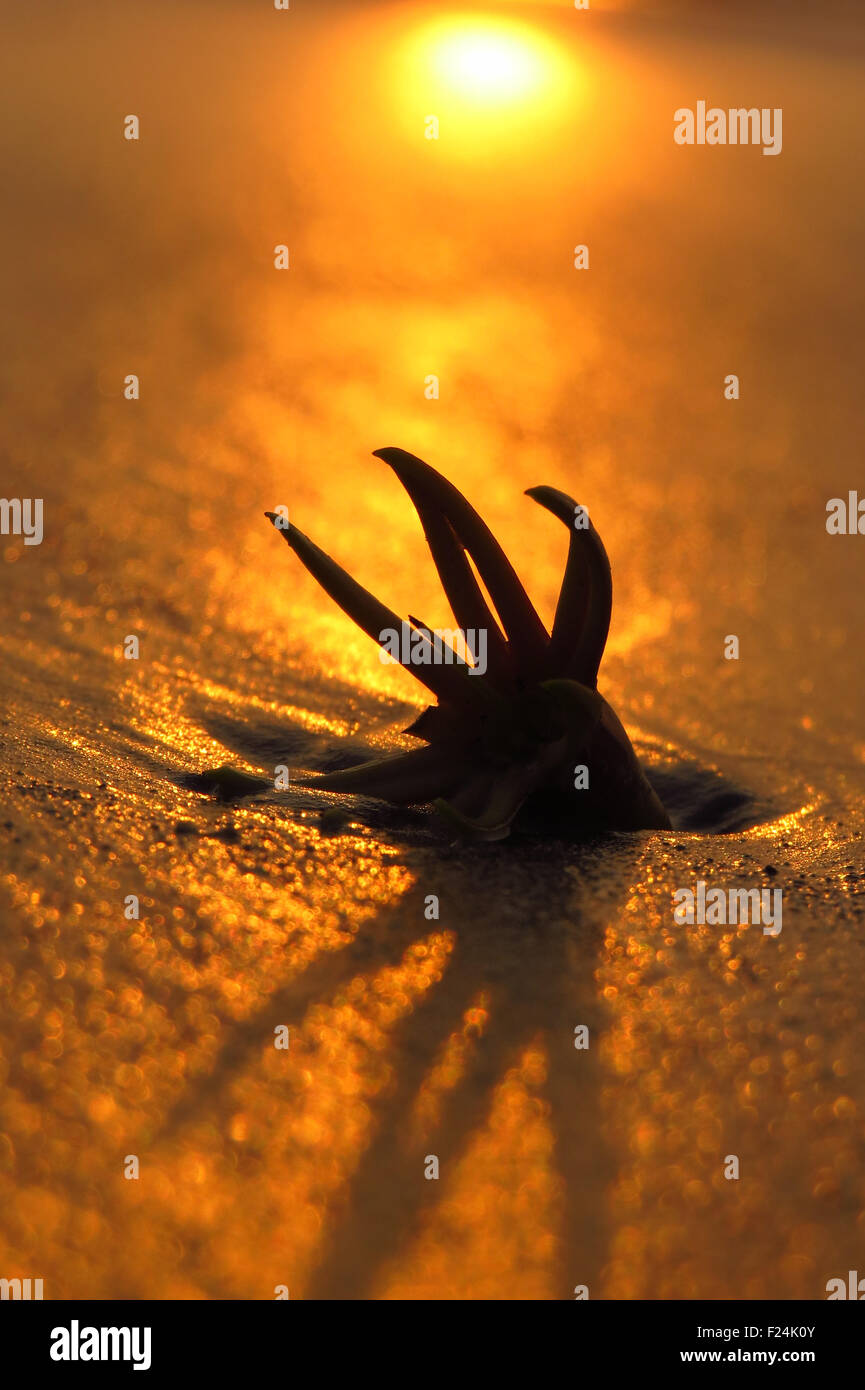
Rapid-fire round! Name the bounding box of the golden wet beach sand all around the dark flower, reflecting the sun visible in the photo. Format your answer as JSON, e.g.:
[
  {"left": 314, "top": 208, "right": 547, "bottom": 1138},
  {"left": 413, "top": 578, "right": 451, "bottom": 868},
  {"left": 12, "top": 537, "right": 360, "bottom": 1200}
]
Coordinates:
[{"left": 0, "top": 4, "right": 865, "bottom": 1300}]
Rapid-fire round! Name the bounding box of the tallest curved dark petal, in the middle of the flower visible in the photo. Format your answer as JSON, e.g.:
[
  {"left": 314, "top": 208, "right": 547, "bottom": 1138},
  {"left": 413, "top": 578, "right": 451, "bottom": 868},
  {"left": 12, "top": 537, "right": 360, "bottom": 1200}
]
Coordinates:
[{"left": 373, "top": 448, "right": 549, "bottom": 676}]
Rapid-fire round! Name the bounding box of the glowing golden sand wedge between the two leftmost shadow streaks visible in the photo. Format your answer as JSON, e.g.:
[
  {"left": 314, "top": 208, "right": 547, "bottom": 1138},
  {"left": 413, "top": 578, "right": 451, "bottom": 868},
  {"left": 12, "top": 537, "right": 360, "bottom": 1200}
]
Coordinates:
[{"left": 136, "top": 931, "right": 453, "bottom": 1298}]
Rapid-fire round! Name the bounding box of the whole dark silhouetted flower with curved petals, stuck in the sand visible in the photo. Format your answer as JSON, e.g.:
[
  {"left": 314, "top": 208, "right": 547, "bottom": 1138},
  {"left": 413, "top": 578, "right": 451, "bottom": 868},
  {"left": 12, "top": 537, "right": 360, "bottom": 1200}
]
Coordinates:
[{"left": 264, "top": 445, "right": 669, "bottom": 841}]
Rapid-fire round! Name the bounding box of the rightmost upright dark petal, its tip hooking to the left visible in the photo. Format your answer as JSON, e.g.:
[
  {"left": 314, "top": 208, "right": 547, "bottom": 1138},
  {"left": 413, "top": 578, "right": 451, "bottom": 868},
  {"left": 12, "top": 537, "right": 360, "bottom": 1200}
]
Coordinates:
[{"left": 526, "top": 488, "right": 613, "bottom": 688}]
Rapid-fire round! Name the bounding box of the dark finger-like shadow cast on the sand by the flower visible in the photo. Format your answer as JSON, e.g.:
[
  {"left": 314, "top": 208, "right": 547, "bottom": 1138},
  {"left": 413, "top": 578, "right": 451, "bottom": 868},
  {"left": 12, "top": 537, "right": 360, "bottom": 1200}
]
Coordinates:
[{"left": 150, "top": 695, "right": 784, "bottom": 1298}]
